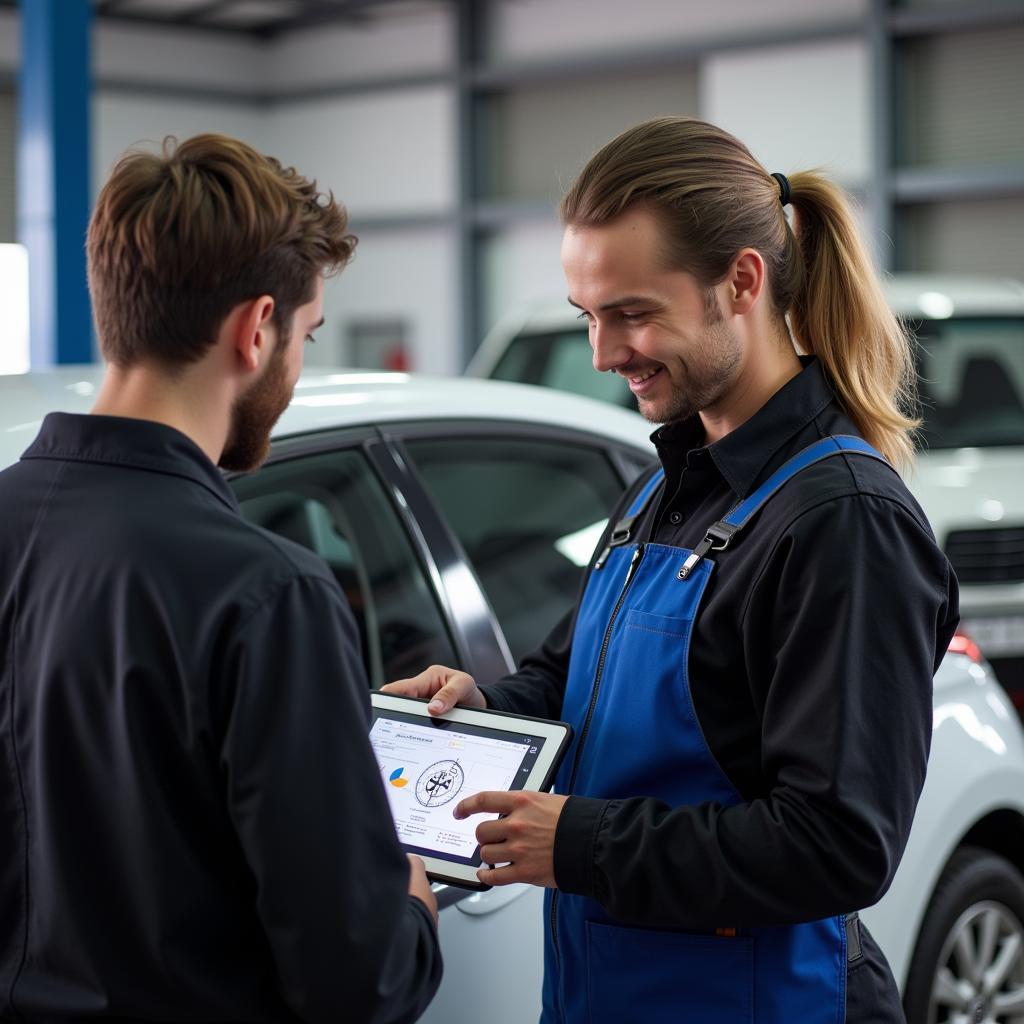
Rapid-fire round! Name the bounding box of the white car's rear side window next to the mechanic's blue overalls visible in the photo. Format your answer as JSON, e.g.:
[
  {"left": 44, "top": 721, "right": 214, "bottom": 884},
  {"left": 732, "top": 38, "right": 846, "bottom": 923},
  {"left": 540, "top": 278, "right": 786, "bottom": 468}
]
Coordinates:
[{"left": 406, "top": 437, "right": 623, "bottom": 663}]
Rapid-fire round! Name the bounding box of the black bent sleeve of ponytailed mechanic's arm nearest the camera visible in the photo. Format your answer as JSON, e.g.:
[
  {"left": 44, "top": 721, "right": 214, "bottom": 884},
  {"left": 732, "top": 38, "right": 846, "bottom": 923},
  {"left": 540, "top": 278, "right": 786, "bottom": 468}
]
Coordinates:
[{"left": 555, "top": 495, "right": 957, "bottom": 929}]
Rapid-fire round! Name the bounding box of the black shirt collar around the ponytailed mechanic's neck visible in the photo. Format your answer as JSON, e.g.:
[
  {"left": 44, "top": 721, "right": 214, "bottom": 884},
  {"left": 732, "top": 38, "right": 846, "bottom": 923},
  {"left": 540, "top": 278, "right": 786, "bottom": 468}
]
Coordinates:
[{"left": 651, "top": 356, "right": 835, "bottom": 498}]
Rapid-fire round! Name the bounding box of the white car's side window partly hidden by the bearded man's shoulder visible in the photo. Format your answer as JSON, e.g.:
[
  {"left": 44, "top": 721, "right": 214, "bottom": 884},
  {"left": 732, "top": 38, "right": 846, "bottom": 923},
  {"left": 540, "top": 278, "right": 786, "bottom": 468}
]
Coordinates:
[{"left": 232, "top": 451, "right": 458, "bottom": 687}]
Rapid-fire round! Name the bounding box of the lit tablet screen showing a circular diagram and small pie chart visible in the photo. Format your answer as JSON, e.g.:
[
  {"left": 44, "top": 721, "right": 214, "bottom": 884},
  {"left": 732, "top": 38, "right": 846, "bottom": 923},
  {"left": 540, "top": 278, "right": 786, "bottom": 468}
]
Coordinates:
[{"left": 370, "top": 708, "right": 549, "bottom": 867}]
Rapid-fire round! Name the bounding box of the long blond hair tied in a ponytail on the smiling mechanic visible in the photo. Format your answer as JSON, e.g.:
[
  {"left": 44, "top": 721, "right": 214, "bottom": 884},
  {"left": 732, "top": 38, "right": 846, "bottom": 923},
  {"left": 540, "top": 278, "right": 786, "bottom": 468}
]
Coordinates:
[{"left": 560, "top": 118, "right": 920, "bottom": 468}]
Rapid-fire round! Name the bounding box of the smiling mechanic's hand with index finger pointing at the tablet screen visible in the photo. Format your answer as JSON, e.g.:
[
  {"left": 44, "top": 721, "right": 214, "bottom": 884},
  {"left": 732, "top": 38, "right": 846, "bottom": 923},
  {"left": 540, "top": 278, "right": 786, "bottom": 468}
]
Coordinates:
[{"left": 455, "top": 790, "right": 568, "bottom": 889}]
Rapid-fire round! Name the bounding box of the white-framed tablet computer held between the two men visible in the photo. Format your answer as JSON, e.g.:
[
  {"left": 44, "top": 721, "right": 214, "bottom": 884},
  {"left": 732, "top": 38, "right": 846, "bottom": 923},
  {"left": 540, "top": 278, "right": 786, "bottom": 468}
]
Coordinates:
[{"left": 370, "top": 690, "right": 572, "bottom": 890}]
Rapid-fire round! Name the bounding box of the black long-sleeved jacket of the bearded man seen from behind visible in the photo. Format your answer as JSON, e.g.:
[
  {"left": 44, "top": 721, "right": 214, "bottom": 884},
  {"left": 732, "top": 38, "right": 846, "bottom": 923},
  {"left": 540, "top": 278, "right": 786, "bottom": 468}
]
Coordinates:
[{"left": 0, "top": 415, "right": 440, "bottom": 1024}]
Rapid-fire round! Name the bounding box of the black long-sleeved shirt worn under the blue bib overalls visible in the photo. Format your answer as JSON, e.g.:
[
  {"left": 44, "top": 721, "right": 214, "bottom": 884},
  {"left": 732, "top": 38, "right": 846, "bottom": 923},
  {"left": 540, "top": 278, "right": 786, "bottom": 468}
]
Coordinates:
[{"left": 483, "top": 360, "right": 958, "bottom": 929}]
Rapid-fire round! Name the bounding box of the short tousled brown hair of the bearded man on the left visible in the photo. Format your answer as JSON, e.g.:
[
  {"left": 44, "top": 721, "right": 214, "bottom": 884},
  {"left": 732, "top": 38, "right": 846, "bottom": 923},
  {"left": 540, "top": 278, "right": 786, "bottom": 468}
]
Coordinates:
[{"left": 87, "top": 134, "right": 356, "bottom": 370}]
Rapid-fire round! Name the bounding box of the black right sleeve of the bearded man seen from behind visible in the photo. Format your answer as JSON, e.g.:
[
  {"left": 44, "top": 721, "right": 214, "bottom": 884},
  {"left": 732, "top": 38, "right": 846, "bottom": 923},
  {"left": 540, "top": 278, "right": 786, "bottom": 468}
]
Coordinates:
[{"left": 221, "top": 575, "right": 441, "bottom": 1024}]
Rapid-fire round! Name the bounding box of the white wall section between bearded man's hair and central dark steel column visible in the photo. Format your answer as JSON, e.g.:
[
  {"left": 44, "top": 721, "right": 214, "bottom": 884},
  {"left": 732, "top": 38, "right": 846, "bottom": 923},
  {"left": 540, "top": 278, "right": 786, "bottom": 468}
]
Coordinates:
[{"left": 265, "top": 5, "right": 461, "bottom": 374}]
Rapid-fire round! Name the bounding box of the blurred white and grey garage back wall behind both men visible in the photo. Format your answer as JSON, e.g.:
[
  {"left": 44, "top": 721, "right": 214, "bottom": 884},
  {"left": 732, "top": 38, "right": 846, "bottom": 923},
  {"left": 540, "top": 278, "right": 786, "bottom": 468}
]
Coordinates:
[{"left": 0, "top": 0, "right": 1024, "bottom": 371}]
